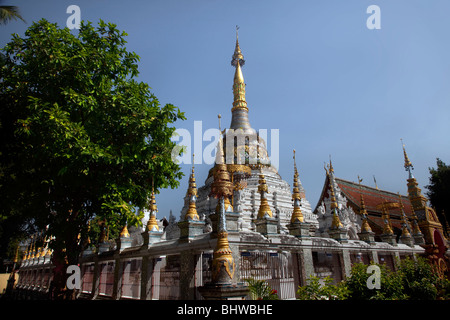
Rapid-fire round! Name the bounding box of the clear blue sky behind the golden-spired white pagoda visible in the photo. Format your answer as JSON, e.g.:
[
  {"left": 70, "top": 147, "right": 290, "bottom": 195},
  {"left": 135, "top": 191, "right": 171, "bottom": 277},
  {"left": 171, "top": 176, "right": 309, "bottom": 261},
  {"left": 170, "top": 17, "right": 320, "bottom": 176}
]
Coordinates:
[{"left": 0, "top": 0, "right": 450, "bottom": 218}]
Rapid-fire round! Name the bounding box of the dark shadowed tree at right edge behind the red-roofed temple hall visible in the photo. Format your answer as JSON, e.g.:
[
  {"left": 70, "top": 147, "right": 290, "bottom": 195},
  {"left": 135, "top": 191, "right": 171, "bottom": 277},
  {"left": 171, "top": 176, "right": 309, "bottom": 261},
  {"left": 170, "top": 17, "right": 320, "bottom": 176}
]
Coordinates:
[{"left": 426, "top": 158, "right": 450, "bottom": 234}]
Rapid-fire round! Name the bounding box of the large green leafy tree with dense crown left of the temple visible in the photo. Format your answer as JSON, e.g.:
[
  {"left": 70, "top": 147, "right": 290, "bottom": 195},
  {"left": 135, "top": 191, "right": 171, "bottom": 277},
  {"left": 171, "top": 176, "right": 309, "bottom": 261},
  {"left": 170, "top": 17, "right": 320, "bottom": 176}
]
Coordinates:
[{"left": 0, "top": 19, "right": 185, "bottom": 296}]
